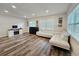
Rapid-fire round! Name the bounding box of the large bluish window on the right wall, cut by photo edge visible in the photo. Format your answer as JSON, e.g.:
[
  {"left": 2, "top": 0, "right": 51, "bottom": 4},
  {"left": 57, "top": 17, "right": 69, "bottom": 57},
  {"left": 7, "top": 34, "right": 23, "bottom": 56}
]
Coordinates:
[{"left": 67, "top": 5, "right": 79, "bottom": 41}]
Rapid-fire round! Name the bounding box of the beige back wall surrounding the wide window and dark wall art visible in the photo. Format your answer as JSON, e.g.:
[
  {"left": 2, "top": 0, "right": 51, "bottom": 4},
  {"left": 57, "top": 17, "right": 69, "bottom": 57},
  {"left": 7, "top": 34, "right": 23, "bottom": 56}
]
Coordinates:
[{"left": 28, "top": 14, "right": 67, "bottom": 31}]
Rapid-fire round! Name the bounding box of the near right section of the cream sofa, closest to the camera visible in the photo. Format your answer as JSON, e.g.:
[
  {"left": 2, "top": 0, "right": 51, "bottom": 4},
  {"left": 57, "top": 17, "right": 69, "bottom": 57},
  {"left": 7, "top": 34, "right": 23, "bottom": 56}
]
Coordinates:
[{"left": 49, "top": 35, "right": 70, "bottom": 50}]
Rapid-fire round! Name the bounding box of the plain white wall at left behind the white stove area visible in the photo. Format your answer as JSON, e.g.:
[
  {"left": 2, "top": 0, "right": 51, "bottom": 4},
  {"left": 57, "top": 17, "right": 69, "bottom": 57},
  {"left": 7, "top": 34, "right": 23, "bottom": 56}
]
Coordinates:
[{"left": 0, "top": 15, "right": 25, "bottom": 37}]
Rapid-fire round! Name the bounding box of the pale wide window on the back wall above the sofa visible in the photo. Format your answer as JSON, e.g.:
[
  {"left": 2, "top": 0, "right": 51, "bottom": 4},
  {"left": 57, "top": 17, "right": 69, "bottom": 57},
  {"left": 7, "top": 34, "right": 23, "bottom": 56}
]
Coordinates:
[{"left": 39, "top": 19, "right": 57, "bottom": 31}]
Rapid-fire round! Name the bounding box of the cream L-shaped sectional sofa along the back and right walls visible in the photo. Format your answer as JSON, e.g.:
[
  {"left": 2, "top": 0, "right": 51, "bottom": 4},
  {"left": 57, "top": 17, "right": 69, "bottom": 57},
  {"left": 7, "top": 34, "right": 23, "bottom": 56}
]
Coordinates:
[{"left": 36, "top": 31, "right": 70, "bottom": 50}]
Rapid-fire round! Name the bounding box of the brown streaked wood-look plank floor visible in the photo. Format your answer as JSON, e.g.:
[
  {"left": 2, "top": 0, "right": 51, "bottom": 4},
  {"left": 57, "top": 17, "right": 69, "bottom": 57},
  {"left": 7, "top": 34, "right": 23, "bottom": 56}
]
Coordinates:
[{"left": 0, "top": 33, "right": 70, "bottom": 56}]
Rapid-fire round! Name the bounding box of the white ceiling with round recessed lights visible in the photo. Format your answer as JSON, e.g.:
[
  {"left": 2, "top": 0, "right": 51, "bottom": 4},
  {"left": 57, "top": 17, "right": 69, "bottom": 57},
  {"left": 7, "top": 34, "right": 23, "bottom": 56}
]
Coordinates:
[{"left": 0, "top": 3, "right": 70, "bottom": 18}]
